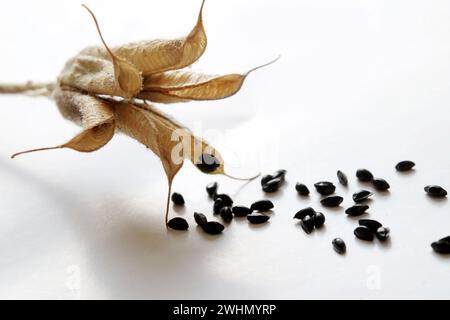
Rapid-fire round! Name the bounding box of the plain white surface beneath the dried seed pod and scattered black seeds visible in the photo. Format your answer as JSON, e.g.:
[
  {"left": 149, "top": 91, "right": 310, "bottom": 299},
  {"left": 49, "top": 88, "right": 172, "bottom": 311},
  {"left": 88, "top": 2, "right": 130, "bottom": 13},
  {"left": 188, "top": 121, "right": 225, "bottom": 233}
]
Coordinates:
[{"left": 0, "top": 0, "right": 450, "bottom": 299}]
